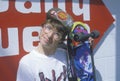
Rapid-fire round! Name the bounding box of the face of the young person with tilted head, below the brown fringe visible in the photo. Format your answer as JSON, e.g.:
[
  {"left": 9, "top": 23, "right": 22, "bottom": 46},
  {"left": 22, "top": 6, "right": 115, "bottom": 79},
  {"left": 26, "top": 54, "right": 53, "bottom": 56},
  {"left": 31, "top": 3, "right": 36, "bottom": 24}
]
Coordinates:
[{"left": 40, "top": 23, "right": 62, "bottom": 48}]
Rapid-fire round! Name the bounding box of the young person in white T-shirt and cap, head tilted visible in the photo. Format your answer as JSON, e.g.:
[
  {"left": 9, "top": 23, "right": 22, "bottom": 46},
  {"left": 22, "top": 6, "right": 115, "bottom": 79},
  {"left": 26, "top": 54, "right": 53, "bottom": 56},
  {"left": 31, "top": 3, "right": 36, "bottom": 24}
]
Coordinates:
[{"left": 16, "top": 8, "right": 73, "bottom": 81}]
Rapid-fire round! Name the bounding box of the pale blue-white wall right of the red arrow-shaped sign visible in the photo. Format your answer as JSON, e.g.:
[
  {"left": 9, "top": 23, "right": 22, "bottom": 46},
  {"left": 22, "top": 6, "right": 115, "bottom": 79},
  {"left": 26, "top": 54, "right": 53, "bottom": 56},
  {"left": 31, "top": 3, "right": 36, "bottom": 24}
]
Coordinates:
[{"left": 94, "top": 0, "right": 120, "bottom": 81}]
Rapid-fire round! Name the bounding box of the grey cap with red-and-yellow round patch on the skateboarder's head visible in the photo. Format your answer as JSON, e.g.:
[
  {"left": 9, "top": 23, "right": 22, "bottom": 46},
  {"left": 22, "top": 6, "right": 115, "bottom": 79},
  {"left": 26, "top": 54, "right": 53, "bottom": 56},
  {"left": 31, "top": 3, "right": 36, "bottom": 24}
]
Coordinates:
[{"left": 47, "top": 8, "right": 73, "bottom": 30}]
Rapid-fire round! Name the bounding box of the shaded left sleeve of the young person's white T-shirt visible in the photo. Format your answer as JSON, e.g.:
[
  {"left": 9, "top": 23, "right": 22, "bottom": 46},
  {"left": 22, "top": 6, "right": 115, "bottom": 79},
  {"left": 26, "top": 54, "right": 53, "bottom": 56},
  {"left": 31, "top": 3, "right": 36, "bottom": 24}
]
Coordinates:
[{"left": 16, "top": 62, "right": 34, "bottom": 81}]
